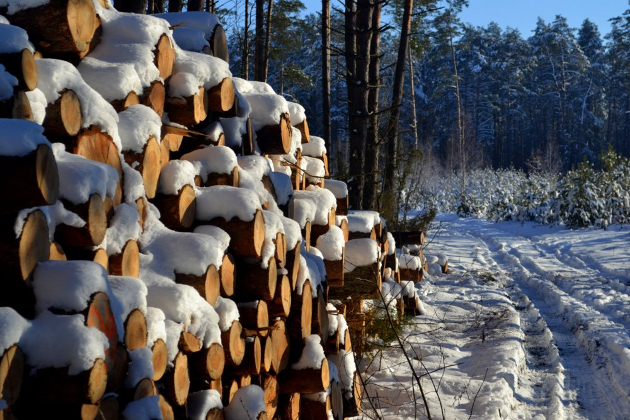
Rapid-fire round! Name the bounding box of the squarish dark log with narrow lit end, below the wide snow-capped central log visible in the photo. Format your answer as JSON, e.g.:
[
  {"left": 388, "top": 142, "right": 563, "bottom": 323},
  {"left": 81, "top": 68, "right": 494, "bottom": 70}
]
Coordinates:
[{"left": 236, "top": 257, "right": 278, "bottom": 301}]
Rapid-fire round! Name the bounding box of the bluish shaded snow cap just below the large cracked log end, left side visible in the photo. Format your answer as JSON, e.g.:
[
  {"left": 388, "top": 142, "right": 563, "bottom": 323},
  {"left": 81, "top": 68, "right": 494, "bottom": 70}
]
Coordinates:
[{"left": 52, "top": 143, "right": 118, "bottom": 204}]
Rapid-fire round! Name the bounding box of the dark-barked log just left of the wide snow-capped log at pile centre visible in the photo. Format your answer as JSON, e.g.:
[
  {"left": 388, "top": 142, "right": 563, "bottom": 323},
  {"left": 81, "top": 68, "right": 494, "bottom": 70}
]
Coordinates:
[{"left": 151, "top": 185, "right": 197, "bottom": 232}]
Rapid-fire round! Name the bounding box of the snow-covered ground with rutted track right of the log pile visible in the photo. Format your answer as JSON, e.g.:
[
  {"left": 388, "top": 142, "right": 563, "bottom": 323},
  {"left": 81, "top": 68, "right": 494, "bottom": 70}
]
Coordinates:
[{"left": 363, "top": 215, "right": 630, "bottom": 419}]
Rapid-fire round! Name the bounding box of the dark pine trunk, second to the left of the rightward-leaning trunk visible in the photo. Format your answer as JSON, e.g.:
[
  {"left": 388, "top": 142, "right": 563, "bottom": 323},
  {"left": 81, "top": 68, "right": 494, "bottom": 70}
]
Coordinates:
[{"left": 348, "top": 0, "right": 373, "bottom": 209}]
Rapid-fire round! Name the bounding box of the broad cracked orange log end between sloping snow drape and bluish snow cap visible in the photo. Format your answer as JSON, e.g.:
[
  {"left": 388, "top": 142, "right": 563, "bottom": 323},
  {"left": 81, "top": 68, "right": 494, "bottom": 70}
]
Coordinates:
[{"left": 69, "top": 125, "right": 123, "bottom": 206}]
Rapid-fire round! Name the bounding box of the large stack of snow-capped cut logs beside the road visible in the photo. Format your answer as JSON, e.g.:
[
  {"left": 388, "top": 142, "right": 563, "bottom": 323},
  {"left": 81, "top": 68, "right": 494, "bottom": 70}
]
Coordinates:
[{"left": 0, "top": 0, "right": 434, "bottom": 420}]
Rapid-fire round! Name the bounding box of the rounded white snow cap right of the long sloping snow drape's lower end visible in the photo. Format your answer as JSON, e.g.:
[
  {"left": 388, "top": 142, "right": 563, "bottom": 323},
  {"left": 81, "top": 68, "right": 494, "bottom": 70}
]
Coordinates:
[{"left": 118, "top": 105, "right": 162, "bottom": 153}]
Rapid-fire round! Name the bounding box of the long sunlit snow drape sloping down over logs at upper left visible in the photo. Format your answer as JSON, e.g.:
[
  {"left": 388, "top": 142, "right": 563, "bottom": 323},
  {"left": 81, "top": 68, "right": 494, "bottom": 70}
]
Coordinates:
[{"left": 36, "top": 58, "right": 122, "bottom": 151}]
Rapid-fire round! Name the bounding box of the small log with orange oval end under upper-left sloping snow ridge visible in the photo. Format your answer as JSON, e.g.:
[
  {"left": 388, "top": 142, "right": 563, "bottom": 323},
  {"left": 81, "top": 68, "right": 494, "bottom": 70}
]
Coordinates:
[{"left": 42, "top": 89, "right": 83, "bottom": 137}]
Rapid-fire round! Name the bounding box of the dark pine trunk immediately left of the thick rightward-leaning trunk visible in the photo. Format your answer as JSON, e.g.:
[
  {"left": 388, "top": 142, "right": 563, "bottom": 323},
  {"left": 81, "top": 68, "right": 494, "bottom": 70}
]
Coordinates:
[{"left": 363, "top": 0, "right": 381, "bottom": 210}]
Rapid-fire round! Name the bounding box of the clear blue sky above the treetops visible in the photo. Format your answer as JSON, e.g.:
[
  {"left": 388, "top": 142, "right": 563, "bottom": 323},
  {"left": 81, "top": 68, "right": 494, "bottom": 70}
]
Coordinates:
[{"left": 302, "top": 0, "right": 630, "bottom": 38}]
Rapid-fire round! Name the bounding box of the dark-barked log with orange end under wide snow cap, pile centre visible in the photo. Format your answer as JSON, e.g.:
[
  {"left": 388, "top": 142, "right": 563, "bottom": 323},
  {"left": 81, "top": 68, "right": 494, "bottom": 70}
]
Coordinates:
[{"left": 196, "top": 210, "right": 265, "bottom": 258}]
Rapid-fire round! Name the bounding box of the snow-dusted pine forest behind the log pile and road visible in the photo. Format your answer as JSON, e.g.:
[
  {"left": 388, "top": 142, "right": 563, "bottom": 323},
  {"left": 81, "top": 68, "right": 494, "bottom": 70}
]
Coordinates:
[{"left": 116, "top": 0, "right": 630, "bottom": 223}]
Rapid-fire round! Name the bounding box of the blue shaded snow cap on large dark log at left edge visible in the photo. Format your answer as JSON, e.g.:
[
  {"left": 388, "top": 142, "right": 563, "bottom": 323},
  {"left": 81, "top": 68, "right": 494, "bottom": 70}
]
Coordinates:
[{"left": 0, "top": 118, "right": 51, "bottom": 157}]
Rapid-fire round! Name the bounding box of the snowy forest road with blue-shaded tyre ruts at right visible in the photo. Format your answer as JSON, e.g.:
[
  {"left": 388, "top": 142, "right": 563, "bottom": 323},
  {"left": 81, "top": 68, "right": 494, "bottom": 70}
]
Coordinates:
[{"left": 427, "top": 216, "right": 630, "bottom": 419}]
